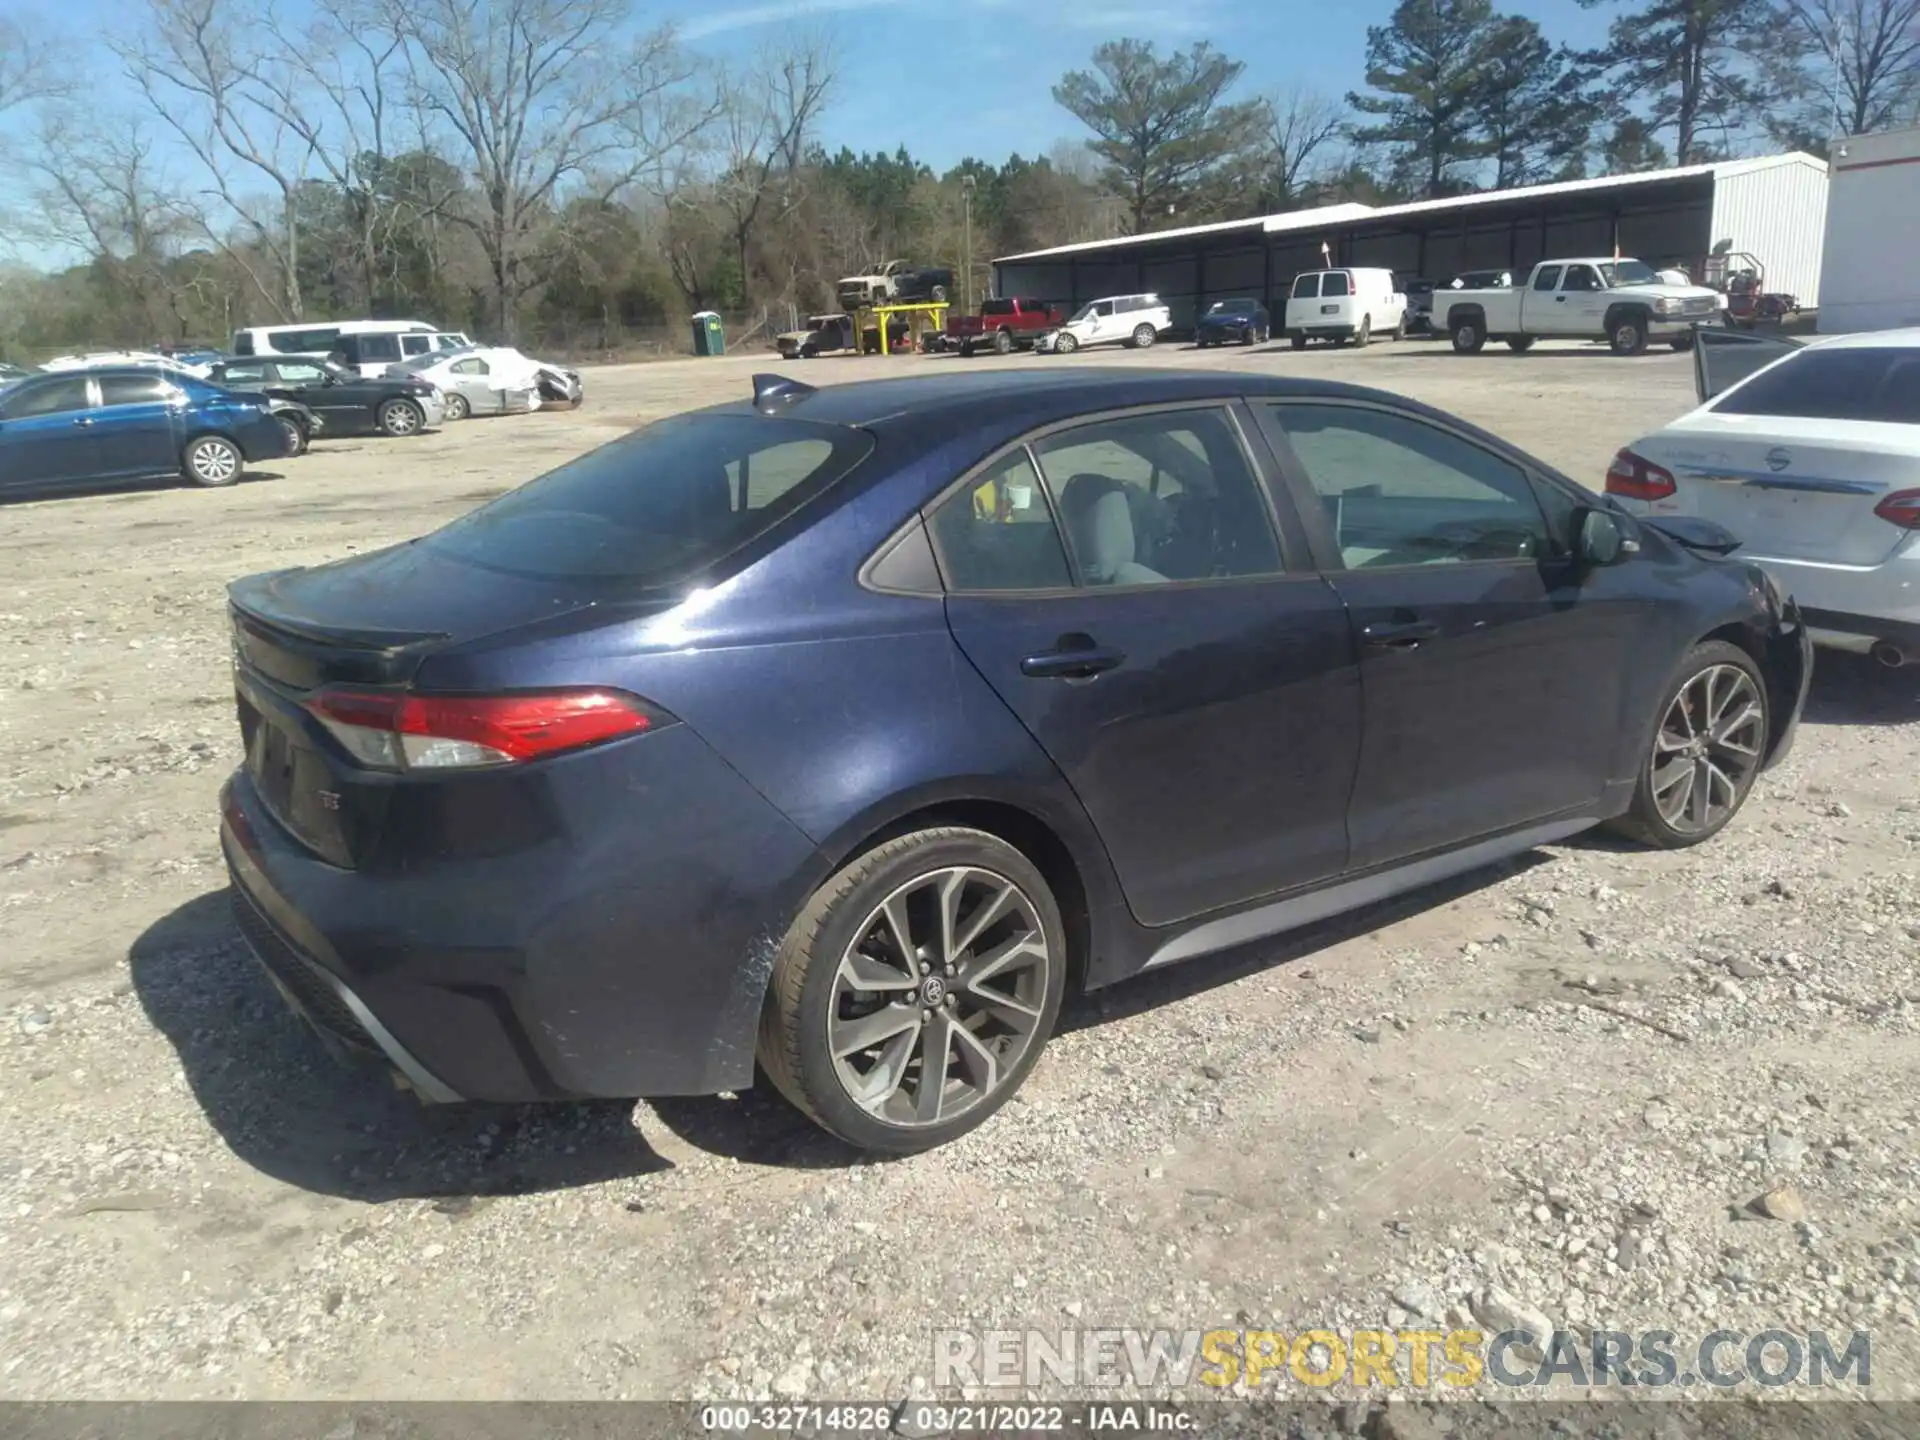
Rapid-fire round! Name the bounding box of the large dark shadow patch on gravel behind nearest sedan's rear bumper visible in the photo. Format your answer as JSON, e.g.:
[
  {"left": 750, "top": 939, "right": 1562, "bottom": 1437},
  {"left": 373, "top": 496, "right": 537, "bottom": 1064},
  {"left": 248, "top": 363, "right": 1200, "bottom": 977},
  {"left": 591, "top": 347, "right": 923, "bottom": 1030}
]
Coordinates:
[{"left": 127, "top": 889, "right": 670, "bottom": 1210}]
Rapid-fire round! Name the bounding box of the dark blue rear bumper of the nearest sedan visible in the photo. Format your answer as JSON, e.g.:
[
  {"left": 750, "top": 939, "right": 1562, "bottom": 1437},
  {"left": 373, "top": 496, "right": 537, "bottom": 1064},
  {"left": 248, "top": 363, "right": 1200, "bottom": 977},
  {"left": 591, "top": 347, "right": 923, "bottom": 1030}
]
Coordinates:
[{"left": 221, "top": 726, "right": 820, "bottom": 1102}]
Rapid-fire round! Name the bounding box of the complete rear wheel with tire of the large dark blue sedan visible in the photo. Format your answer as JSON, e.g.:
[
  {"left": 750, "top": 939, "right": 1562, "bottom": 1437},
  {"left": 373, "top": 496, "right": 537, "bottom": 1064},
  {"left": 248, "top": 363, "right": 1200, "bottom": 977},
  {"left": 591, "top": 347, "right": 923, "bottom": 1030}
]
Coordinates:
[{"left": 760, "top": 828, "right": 1066, "bottom": 1154}]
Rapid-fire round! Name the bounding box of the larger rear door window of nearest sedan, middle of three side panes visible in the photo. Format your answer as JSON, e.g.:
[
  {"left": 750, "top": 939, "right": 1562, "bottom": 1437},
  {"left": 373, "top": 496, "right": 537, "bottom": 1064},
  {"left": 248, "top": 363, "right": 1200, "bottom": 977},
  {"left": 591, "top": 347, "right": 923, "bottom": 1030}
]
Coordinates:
[{"left": 1033, "top": 409, "right": 1281, "bottom": 586}]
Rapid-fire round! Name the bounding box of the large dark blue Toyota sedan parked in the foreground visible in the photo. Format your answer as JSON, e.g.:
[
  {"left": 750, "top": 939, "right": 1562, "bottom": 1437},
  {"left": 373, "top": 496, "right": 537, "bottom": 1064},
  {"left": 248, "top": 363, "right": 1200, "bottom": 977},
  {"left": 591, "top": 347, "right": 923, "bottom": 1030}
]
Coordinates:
[{"left": 221, "top": 369, "right": 1811, "bottom": 1152}]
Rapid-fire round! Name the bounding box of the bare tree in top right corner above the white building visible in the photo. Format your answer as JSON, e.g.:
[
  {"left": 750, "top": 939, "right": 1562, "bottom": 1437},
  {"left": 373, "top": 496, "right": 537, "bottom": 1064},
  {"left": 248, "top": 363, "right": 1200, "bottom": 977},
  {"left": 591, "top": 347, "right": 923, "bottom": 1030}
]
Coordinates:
[{"left": 1782, "top": 0, "right": 1920, "bottom": 134}]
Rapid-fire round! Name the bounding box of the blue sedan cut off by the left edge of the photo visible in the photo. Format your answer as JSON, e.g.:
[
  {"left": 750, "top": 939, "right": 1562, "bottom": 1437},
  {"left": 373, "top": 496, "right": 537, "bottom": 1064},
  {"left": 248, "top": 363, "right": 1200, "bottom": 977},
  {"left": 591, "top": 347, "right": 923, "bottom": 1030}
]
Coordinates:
[{"left": 0, "top": 367, "right": 288, "bottom": 495}]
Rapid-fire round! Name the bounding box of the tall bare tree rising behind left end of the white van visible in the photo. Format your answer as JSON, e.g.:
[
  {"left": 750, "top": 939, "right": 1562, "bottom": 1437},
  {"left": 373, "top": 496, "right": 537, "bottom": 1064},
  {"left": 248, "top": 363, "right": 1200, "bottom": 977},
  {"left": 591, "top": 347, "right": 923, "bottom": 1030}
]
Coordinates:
[{"left": 115, "top": 0, "right": 313, "bottom": 321}]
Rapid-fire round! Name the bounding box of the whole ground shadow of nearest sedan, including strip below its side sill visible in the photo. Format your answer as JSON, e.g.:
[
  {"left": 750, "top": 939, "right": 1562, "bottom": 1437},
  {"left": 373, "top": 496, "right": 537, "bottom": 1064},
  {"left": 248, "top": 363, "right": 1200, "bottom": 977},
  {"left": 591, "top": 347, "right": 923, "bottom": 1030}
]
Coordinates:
[{"left": 142, "top": 851, "right": 1548, "bottom": 1213}]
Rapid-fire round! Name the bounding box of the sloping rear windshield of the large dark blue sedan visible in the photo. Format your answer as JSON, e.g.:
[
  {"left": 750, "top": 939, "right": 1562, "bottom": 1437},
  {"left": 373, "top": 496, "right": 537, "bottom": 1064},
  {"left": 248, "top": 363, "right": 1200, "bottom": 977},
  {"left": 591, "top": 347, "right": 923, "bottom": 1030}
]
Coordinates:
[{"left": 420, "top": 413, "right": 874, "bottom": 586}]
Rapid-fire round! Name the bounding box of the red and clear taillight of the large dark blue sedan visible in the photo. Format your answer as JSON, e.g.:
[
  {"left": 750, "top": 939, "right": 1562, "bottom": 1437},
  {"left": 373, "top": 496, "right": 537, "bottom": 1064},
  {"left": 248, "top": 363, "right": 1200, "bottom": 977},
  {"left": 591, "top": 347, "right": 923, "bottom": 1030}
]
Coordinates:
[{"left": 307, "top": 689, "right": 662, "bottom": 770}]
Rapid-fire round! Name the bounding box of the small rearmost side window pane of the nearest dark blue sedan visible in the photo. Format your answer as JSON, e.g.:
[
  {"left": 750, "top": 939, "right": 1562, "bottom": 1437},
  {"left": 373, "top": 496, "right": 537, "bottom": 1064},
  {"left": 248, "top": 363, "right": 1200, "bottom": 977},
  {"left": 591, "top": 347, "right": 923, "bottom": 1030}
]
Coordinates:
[{"left": 929, "top": 447, "right": 1073, "bottom": 591}]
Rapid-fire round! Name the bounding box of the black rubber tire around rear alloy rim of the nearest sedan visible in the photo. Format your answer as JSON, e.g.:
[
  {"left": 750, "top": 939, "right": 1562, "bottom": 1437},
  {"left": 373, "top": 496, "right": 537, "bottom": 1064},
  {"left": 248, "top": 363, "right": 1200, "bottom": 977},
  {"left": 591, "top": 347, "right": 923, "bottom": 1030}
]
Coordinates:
[{"left": 758, "top": 826, "right": 1068, "bottom": 1154}]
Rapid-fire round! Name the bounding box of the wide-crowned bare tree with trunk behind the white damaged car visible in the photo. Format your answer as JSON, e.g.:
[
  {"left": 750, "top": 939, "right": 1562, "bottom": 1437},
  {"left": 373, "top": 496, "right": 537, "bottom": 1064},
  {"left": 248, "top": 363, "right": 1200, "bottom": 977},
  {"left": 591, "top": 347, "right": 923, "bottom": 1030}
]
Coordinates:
[{"left": 388, "top": 0, "right": 712, "bottom": 340}]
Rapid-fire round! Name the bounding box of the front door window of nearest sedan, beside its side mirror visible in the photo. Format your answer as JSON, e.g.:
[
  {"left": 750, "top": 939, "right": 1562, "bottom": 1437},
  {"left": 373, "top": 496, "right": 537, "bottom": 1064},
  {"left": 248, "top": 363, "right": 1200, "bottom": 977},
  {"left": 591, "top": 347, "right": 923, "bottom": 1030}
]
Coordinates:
[{"left": 1273, "top": 405, "right": 1559, "bottom": 570}]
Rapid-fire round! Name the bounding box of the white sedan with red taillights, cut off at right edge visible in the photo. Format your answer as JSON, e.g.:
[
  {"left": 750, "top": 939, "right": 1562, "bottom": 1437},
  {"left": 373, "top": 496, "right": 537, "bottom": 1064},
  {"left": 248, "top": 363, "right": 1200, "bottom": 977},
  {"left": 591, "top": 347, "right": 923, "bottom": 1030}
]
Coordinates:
[{"left": 1607, "top": 328, "right": 1920, "bottom": 666}]
